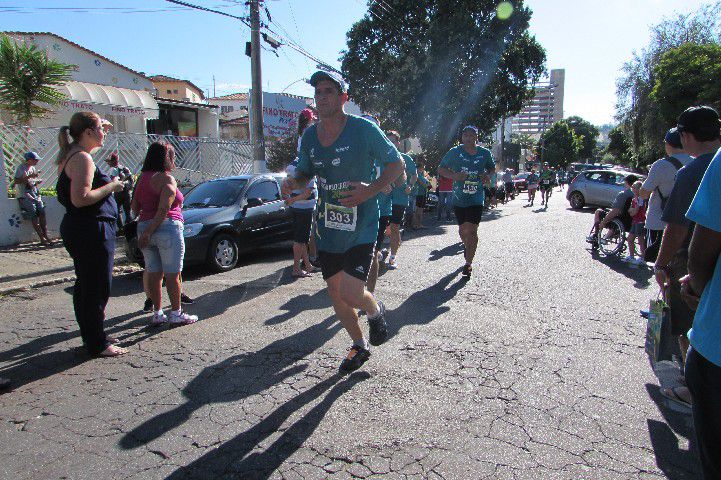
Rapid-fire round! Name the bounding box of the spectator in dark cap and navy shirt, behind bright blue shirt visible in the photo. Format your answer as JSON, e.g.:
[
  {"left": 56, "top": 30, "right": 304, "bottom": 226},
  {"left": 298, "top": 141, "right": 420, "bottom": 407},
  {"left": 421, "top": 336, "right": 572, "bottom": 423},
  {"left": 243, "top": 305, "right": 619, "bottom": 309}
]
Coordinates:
[{"left": 654, "top": 106, "right": 721, "bottom": 402}]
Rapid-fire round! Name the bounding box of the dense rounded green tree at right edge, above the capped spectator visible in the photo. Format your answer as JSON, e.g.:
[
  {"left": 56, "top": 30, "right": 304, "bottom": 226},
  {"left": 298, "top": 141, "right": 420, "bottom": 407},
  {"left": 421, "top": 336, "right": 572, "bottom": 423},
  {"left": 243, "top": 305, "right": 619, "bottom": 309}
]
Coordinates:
[{"left": 651, "top": 43, "right": 721, "bottom": 125}]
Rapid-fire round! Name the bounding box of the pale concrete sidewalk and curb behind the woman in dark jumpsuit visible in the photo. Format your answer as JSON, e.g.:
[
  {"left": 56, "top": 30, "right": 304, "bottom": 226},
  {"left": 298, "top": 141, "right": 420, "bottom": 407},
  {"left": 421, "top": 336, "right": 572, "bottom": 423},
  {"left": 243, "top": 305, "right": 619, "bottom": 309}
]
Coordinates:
[{"left": 0, "top": 237, "right": 141, "bottom": 295}]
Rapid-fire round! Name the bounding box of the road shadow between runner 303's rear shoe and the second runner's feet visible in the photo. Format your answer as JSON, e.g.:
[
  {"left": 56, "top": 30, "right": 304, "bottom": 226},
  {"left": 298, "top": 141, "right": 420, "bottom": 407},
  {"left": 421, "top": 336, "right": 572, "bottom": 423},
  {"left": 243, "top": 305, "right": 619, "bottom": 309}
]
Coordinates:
[{"left": 386, "top": 268, "right": 468, "bottom": 338}]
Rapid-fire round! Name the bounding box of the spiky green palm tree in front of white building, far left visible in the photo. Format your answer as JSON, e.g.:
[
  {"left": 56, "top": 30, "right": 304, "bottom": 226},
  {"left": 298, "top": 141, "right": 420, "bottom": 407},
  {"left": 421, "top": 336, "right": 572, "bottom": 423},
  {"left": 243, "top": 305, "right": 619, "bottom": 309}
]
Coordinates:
[{"left": 0, "top": 35, "right": 76, "bottom": 125}]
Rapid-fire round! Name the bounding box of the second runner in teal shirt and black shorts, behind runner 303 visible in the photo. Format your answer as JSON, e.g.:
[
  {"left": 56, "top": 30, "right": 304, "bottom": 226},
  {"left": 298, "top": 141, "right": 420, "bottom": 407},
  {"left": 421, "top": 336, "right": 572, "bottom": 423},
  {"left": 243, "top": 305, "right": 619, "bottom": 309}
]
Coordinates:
[{"left": 438, "top": 125, "right": 496, "bottom": 277}]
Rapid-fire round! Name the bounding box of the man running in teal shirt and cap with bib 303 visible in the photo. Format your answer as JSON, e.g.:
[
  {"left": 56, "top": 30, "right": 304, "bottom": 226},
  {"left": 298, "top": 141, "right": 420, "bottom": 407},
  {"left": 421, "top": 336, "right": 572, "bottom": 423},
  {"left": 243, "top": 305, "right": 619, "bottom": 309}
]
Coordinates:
[{"left": 283, "top": 71, "right": 403, "bottom": 372}]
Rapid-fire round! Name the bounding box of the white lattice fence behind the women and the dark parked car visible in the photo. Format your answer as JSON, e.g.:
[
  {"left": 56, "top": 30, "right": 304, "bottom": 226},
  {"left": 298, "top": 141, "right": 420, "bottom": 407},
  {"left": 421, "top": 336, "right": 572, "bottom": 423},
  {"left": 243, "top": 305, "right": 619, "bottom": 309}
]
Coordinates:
[{"left": 0, "top": 125, "right": 253, "bottom": 188}]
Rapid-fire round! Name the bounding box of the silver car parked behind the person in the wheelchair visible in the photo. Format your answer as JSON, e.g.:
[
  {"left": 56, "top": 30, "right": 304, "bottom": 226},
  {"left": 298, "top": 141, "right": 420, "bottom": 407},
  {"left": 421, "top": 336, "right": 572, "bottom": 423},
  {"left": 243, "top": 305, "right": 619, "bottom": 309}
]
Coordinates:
[{"left": 566, "top": 169, "right": 644, "bottom": 209}]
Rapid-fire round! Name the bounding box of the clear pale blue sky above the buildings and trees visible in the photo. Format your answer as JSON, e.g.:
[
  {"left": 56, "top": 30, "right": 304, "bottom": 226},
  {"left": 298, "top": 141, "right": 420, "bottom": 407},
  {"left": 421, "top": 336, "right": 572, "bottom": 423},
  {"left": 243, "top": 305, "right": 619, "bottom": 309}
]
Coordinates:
[{"left": 0, "top": 0, "right": 710, "bottom": 124}]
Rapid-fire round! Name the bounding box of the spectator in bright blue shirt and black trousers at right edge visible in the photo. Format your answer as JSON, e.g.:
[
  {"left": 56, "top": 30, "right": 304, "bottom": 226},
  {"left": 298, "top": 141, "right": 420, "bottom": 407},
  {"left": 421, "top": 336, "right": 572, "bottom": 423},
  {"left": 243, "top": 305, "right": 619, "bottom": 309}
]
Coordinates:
[{"left": 683, "top": 146, "right": 721, "bottom": 480}]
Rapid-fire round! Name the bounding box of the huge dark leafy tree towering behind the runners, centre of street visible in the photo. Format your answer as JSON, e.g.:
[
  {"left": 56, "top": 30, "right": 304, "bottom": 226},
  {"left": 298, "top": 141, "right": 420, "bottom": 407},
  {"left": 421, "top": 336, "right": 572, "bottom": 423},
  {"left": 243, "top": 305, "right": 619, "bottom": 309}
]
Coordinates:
[{"left": 341, "top": 0, "right": 546, "bottom": 167}]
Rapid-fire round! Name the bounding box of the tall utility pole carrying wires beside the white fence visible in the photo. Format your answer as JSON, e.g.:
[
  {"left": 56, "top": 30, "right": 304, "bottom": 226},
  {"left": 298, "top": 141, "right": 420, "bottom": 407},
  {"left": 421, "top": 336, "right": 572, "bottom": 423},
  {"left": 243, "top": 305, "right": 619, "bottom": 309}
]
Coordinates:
[{"left": 249, "top": 0, "right": 266, "bottom": 173}]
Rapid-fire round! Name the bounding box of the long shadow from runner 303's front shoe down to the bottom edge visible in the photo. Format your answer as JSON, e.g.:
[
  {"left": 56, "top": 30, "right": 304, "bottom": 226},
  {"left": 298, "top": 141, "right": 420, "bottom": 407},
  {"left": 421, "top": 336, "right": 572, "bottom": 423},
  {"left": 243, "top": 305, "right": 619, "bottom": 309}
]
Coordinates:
[{"left": 166, "top": 372, "right": 370, "bottom": 480}]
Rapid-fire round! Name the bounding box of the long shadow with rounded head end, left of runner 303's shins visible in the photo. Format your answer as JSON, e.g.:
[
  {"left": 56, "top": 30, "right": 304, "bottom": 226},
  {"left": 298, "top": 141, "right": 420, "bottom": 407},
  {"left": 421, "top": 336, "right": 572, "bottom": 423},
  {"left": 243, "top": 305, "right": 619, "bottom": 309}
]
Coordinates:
[{"left": 119, "top": 316, "right": 341, "bottom": 449}]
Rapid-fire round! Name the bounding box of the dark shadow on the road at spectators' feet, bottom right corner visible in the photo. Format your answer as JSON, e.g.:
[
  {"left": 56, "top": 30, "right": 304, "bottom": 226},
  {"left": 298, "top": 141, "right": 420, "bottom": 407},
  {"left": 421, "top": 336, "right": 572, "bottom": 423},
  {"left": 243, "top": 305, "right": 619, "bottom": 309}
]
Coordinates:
[{"left": 646, "top": 384, "right": 701, "bottom": 480}]
